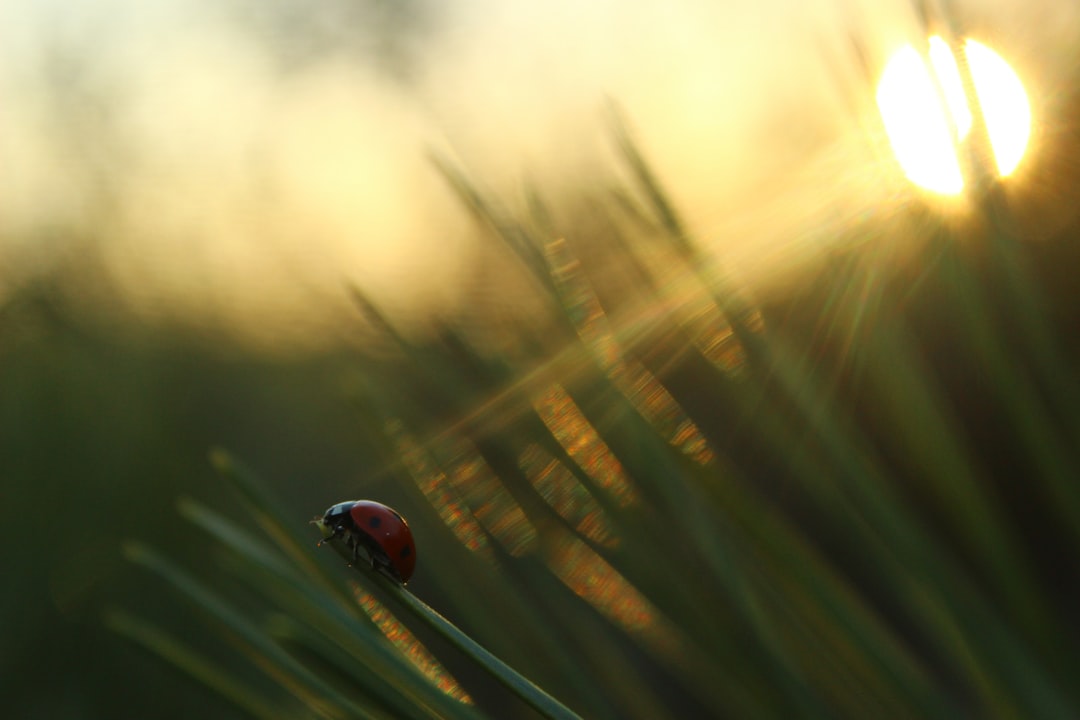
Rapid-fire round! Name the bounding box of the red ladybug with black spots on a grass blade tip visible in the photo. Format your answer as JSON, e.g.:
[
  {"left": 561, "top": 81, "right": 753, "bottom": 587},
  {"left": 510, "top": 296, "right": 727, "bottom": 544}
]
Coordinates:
[{"left": 315, "top": 500, "right": 416, "bottom": 583}]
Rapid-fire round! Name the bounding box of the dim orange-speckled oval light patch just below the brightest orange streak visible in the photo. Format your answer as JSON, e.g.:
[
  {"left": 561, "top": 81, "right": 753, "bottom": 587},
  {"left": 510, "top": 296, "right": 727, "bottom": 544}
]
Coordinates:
[{"left": 517, "top": 443, "right": 618, "bottom": 547}]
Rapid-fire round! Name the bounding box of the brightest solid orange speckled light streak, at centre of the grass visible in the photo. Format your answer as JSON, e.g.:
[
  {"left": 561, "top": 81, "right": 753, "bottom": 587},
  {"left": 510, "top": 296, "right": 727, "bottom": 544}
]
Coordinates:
[{"left": 532, "top": 384, "right": 637, "bottom": 507}]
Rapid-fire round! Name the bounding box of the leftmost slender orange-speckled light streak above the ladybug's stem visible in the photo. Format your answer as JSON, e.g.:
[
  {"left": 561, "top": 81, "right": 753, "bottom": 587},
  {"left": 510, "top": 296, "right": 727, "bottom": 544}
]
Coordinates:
[{"left": 386, "top": 420, "right": 495, "bottom": 561}]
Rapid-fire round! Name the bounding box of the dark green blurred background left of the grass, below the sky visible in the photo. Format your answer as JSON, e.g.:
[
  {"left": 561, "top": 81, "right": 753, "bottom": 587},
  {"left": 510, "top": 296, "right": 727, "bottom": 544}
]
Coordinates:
[{"left": 0, "top": 277, "right": 386, "bottom": 718}]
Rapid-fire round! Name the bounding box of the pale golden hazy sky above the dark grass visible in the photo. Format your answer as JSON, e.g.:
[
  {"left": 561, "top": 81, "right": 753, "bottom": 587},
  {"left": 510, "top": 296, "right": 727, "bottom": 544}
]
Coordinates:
[{"left": 0, "top": 0, "right": 1080, "bottom": 354}]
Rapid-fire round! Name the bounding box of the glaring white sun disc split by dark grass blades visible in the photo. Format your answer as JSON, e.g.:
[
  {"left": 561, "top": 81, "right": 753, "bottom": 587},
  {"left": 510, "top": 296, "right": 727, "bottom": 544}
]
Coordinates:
[{"left": 877, "top": 36, "right": 1031, "bottom": 194}]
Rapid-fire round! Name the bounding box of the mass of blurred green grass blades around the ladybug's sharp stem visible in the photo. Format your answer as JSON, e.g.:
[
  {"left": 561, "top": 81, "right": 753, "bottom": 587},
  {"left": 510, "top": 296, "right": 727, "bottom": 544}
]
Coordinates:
[{"left": 110, "top": 108, "right": 1080, "bottom": 718}]
